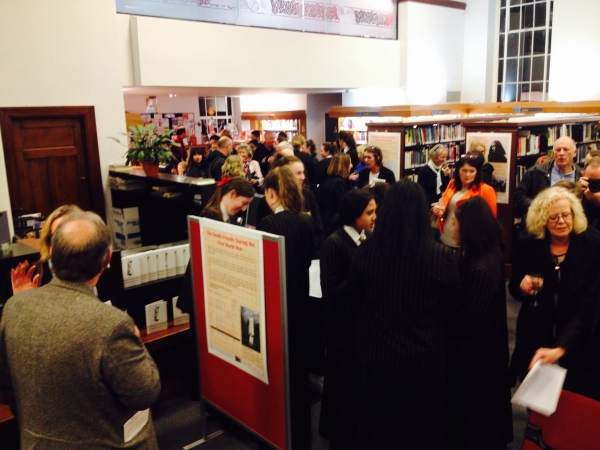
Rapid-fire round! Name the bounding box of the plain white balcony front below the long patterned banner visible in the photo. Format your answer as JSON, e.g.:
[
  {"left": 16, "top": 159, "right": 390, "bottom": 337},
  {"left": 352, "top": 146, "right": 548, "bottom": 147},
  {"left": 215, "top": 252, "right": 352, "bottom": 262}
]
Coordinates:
[{"left": 131, "top": 17, "right": 402, "bottom": 89}]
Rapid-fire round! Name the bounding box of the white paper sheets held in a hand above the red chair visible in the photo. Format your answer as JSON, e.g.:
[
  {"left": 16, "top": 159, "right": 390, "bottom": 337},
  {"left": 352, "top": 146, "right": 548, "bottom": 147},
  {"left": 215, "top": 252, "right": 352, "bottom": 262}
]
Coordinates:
[{"left": 511, "top": 360, "right": 567, "bottom": 416}]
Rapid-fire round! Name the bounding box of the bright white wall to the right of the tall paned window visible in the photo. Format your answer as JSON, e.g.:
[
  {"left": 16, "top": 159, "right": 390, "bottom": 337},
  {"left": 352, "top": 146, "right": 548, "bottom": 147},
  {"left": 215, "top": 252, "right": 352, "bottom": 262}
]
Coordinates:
[{"left": 549, "top": 0, "right": 600, "bottom": 102}]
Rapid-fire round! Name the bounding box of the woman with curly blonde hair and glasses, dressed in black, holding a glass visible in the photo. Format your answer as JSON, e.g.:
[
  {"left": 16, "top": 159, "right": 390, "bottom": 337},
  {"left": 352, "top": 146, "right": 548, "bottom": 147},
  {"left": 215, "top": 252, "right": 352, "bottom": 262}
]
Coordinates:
[{"left": 508, "top": 186, "right": 600, "bottom": 395}]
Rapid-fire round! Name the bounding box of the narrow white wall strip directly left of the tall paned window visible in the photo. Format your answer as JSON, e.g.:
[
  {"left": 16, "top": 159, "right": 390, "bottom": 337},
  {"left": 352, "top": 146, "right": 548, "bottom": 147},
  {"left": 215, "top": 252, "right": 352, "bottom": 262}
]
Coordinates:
[{"left": 460, "top": 0, "right": 499, "bottom": 103}]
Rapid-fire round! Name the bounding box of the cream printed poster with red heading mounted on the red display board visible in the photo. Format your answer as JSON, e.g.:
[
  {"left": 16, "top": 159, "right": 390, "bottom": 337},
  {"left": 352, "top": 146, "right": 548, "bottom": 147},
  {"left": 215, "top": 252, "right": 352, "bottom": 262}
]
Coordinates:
[{"left": 200, "top": 219, "right": 269, "bottom": 384}]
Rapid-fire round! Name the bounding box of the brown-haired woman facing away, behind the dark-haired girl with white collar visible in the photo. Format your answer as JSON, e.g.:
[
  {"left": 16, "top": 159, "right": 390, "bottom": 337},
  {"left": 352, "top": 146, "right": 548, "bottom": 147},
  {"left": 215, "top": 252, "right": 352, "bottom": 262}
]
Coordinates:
[{"left": 320, "top": 153, "right": 354, "bottom": 233}]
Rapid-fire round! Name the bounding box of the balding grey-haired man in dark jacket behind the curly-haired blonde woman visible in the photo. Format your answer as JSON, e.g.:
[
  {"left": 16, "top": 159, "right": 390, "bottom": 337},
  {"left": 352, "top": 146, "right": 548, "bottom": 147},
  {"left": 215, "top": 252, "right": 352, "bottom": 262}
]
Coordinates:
[{"left": 515, "top": 136, "right": 581, "bottom": 228}]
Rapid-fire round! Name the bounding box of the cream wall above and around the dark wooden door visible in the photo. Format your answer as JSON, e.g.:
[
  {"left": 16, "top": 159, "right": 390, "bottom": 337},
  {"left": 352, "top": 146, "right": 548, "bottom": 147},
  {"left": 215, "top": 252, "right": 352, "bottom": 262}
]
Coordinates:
[{"left": 0, "top": 0, "right": 125, "bottom": 232}]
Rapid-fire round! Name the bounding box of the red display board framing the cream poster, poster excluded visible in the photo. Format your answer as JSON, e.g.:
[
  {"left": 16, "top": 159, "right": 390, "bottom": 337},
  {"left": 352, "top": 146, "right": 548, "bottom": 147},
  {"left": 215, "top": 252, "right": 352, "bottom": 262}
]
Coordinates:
[{"left": 188, "top": 216, "right": 291, "bottom": 450}]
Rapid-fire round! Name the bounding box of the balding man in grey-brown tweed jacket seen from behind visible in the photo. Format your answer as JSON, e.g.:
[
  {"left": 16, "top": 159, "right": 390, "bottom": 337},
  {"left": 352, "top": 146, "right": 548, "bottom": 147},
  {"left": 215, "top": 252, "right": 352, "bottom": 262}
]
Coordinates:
[{"left": 0, "top": 212, "right": 160, "bottom": 449}]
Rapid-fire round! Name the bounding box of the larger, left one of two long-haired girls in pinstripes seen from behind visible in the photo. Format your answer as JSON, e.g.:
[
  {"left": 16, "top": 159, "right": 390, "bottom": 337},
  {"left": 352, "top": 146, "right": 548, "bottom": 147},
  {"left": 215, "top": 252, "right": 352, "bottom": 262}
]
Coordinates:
[{"left": 348, "top": 180, "right": 460, "bottom": 450}]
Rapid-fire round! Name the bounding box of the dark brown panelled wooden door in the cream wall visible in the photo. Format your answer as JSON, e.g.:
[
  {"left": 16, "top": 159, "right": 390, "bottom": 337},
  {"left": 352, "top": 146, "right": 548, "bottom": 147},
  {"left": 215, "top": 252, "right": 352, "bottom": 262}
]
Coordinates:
[{"left": 0, "top": 107, "right": 105, "bottom": 218}]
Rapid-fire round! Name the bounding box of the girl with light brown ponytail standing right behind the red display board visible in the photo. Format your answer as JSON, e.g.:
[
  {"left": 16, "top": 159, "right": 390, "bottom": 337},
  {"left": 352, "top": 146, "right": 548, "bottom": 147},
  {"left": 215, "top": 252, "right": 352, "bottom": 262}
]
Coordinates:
[{"left": 258, "top": 166, "right": 315, "bottom": 450}]
